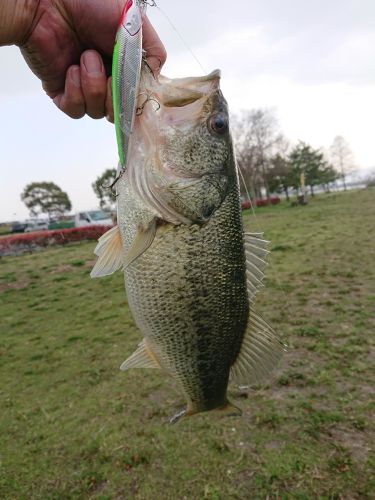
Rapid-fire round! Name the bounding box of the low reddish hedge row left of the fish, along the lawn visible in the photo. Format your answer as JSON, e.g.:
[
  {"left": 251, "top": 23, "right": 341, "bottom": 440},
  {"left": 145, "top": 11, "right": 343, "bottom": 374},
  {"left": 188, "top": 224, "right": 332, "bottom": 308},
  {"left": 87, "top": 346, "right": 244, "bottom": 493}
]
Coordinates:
[{"left": 0, "top": 226, "right": 110, "bottom": 255}]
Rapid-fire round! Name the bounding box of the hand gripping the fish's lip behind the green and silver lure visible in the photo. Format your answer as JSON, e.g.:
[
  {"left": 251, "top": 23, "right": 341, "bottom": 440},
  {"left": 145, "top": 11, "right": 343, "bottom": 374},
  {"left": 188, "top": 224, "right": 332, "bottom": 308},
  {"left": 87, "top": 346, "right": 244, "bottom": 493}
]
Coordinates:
[{"left": 20, "top": 0, "right": 166, "bottom": 122}]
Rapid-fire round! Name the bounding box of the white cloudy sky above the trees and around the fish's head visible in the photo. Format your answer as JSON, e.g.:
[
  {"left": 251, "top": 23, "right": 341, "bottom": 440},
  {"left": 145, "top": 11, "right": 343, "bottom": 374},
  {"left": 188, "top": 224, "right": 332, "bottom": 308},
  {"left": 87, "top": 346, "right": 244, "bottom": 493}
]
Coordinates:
[{"left": 0, "top": 0, "right": 375, "bottom": 221}]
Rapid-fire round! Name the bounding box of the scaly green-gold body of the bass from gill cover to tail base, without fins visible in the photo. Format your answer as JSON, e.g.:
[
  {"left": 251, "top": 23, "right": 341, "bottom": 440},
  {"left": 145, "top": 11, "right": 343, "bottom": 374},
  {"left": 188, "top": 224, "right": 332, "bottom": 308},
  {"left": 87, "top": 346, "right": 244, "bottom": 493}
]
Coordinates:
[{"left": 119, "top": 182, "right": 249, "bottom": 412}]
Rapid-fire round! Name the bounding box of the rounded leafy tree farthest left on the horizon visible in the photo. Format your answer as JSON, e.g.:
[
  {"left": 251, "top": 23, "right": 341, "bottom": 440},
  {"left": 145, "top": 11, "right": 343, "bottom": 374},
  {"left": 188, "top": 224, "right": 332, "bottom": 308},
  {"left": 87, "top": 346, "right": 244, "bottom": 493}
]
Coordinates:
[{"left": 21, "top": 182, "right": 72, "bottom": 219}]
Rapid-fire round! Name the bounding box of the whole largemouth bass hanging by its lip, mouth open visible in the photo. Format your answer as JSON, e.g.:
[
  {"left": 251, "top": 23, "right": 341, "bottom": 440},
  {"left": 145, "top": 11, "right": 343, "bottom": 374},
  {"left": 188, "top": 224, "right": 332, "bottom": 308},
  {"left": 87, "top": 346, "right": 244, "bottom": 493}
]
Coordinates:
[{"left": 91, "top": 64, "right": 283, "bottom": 420}]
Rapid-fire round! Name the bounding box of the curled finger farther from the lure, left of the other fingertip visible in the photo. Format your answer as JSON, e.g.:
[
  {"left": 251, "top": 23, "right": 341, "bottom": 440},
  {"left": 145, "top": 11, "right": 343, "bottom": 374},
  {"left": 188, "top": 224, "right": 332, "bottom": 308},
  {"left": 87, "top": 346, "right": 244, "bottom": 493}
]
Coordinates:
[{"left": 53, "top": 66, "right": 85, "bottom": 118}]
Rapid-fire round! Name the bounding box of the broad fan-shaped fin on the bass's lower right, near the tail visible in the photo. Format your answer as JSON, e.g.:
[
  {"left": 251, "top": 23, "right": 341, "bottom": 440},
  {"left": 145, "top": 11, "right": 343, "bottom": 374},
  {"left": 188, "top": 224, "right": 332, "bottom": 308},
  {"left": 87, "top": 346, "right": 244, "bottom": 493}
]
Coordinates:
[{"left": 230, "top": 311, "right": 286, "bottom": 385}]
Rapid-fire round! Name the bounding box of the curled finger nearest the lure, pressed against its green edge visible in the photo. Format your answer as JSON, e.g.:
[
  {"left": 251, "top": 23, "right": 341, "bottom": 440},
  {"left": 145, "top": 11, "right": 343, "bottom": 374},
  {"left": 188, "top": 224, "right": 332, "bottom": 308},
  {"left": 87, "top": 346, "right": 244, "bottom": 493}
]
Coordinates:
[{"left": 81, "top": 50, "right": 107, "bottom": 118}]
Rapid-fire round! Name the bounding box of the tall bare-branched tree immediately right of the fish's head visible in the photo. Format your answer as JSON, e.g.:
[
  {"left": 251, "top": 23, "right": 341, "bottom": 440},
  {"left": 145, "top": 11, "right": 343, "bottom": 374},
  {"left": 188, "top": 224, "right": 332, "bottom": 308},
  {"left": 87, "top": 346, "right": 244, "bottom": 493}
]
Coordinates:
[{"left": 232, "top": 109, "right": 283, "bottom": 198}]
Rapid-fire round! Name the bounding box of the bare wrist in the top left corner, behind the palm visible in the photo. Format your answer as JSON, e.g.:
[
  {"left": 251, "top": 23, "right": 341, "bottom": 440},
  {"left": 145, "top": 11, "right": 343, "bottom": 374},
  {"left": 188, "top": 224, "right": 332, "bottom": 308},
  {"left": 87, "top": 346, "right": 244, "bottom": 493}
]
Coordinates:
[{"left": 0, "top": 0, "right": 40, "bottom": 45}]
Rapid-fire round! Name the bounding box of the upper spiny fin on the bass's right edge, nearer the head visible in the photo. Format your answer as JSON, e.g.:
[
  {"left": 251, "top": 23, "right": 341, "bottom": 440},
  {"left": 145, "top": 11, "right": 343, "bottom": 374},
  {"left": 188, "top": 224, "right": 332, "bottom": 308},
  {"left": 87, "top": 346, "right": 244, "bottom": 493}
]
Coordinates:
[{"left": 245, "top": 233, "right": 269, "bottom": 302}]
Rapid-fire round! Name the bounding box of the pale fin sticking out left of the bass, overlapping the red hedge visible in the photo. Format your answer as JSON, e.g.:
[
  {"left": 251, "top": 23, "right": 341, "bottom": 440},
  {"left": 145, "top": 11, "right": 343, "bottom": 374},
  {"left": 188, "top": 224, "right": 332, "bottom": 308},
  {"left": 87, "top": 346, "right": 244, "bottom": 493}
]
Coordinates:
[{"left": 90, "top": 226, "right": 124, "bottom": 278}]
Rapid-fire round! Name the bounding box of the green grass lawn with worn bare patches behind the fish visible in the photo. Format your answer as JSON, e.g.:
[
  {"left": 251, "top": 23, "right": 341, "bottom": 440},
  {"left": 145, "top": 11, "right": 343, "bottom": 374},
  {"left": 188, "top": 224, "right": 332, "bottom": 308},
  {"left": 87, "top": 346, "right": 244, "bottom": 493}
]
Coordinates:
[{"left": 0, "top": 190, "right": 375, "bottom": 500}]
